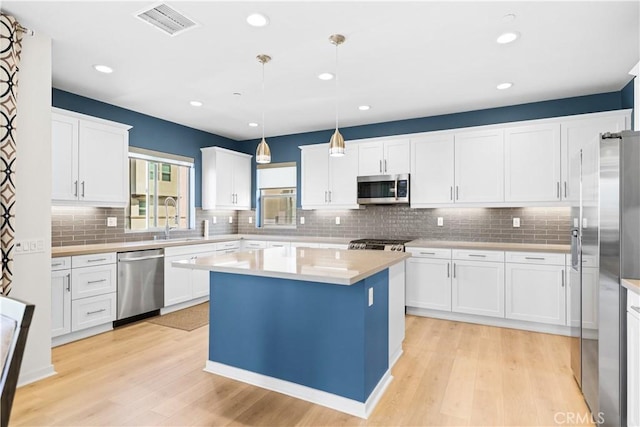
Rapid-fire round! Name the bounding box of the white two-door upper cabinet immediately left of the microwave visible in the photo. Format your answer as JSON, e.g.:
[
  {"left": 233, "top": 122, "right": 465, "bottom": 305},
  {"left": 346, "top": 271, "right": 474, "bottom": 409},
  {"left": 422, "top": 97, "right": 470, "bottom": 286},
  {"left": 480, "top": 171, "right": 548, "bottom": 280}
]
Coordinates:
[{"left": 300, "top": 143, "right": 359, "bottom": 209}]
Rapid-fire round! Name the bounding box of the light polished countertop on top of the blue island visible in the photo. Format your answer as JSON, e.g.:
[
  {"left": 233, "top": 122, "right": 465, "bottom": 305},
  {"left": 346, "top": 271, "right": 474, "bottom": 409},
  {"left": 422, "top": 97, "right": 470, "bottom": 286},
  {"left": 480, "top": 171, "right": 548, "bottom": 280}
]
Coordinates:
[{"left": 172, "top": 247, "right": 411, "bottom": 285}]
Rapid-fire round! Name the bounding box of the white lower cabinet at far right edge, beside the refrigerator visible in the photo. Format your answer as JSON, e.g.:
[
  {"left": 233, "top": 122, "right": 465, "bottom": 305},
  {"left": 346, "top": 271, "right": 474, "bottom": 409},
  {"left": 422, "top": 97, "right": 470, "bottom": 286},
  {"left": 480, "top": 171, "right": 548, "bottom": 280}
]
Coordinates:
[{"left": 627, "top": 291, "right": 640, "bottom": 426}]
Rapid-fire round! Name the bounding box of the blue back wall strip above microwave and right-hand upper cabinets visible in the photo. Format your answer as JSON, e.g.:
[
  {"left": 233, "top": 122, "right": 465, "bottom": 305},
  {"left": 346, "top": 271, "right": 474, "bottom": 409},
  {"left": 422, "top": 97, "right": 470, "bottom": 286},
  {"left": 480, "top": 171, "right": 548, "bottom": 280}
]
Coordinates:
[{"left": 244, "top": 88, "right": 633, "bottom": 207}]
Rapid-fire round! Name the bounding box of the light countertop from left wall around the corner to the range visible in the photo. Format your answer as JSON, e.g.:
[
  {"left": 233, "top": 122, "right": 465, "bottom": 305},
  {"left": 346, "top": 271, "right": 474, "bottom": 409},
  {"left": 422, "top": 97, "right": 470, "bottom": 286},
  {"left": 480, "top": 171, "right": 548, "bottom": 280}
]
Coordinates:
[{"left": 51, "top": 234, "right": 353, "bottom": 258}]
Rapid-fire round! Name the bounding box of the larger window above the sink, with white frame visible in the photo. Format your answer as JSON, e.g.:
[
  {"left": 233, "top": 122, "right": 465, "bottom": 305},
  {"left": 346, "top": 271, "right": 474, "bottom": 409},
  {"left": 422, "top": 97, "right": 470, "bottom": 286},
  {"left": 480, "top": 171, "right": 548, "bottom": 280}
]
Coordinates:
[{"left": 126, "top": 147, "right": 195, "bottom": 231}]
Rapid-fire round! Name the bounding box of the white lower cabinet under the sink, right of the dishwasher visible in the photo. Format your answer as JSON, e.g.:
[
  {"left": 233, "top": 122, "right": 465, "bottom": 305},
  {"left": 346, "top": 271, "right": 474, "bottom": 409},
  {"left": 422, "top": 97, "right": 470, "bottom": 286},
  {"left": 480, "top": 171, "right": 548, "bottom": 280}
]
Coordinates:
[{"left": 164, "top": 242, "right": 219, "bottom": 307}]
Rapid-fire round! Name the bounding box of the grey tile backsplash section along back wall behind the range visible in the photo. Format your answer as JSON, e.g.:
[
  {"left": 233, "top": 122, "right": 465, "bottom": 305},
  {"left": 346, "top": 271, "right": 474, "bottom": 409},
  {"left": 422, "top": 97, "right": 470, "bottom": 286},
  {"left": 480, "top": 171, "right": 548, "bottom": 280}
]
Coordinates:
[{"left": 238, "top": 206, "right": 571, "bottom": 244}]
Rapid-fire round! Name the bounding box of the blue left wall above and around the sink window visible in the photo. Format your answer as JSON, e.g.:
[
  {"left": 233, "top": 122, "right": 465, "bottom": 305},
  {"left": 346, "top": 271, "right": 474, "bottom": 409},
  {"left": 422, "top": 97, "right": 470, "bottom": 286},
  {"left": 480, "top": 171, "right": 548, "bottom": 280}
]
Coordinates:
[{"left": 52, "top": 89, "right": 247, "bottom": 206}]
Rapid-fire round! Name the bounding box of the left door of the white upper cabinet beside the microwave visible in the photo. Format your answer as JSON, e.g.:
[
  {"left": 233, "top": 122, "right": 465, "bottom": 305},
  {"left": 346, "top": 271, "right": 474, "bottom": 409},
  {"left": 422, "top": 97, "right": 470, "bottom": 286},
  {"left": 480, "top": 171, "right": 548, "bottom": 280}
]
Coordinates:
[{"left": 301, "top": 144, "right": 330, "bottom": 209}]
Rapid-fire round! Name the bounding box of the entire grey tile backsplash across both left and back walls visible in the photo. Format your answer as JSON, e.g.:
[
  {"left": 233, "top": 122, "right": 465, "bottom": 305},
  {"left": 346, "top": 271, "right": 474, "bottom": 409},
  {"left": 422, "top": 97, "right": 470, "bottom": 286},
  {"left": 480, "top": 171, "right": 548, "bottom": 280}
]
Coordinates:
[{"left": 51, "top": 206, "right": 571, "bottom": 246}]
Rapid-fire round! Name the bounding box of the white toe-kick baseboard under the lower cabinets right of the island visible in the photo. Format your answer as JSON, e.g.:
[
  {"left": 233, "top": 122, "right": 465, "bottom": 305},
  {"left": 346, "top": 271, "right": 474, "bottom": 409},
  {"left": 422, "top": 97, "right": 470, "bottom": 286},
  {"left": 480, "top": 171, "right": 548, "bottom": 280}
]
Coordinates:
[{"left": 407, "top": 307, "right": 571, "bottom": 336}]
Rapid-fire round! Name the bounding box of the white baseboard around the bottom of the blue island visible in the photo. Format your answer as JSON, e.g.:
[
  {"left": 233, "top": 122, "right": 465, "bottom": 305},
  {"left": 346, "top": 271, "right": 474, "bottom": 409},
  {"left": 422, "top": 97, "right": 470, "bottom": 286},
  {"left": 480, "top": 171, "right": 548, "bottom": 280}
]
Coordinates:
[{"left": 204, "top": 360, "right": 393, "bottom": 419}]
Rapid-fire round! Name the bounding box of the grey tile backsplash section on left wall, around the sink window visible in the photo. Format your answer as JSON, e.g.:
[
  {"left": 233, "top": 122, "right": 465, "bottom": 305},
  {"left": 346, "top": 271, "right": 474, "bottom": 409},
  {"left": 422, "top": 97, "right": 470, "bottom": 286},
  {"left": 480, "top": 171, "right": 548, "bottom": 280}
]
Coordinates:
[{"left": 51, "top": 206, "right": 238, "bottom": 246}]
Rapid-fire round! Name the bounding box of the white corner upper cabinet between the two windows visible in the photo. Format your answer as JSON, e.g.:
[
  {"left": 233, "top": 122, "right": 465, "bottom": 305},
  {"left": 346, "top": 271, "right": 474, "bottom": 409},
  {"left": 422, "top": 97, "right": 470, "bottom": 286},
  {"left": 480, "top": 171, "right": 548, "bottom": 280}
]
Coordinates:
[{"left": 200, "top": 147, "right": 252, "bottom": 210}]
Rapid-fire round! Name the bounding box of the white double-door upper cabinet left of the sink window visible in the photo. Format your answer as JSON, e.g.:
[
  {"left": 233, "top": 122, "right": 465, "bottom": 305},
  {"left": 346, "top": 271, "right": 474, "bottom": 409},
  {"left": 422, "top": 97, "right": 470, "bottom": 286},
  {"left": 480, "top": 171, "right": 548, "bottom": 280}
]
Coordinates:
[{"left": 51, "top": 108, "right": 131, "bottom": 207}]
